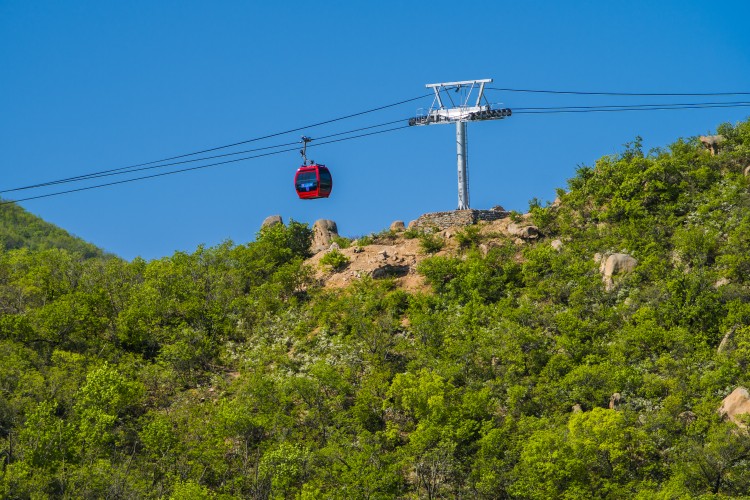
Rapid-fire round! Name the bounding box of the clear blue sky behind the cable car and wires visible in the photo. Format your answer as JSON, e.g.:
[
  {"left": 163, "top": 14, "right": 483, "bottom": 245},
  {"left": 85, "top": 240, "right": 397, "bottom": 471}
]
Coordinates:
[{"left": 0, "top": 0, "right": 750, "bottom": 259}]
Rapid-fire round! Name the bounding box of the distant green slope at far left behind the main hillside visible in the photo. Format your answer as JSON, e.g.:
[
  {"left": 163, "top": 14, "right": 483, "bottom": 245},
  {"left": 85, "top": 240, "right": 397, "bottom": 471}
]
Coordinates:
[{"left": 0, "top": 198, "right": 104, "bottom": 258}]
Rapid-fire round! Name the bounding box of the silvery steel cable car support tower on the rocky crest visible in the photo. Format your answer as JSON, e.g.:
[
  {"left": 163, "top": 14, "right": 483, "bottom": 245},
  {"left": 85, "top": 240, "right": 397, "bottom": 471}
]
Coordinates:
[{"left": 409, "top": 78, "right": 512, "bottom": 210}]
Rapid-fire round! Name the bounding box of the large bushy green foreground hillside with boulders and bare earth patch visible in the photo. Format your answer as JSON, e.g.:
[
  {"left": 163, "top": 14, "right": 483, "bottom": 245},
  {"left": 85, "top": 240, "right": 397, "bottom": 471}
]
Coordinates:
[{"left": 0, "top": 117, "right": 750, "bottom": 499}]
